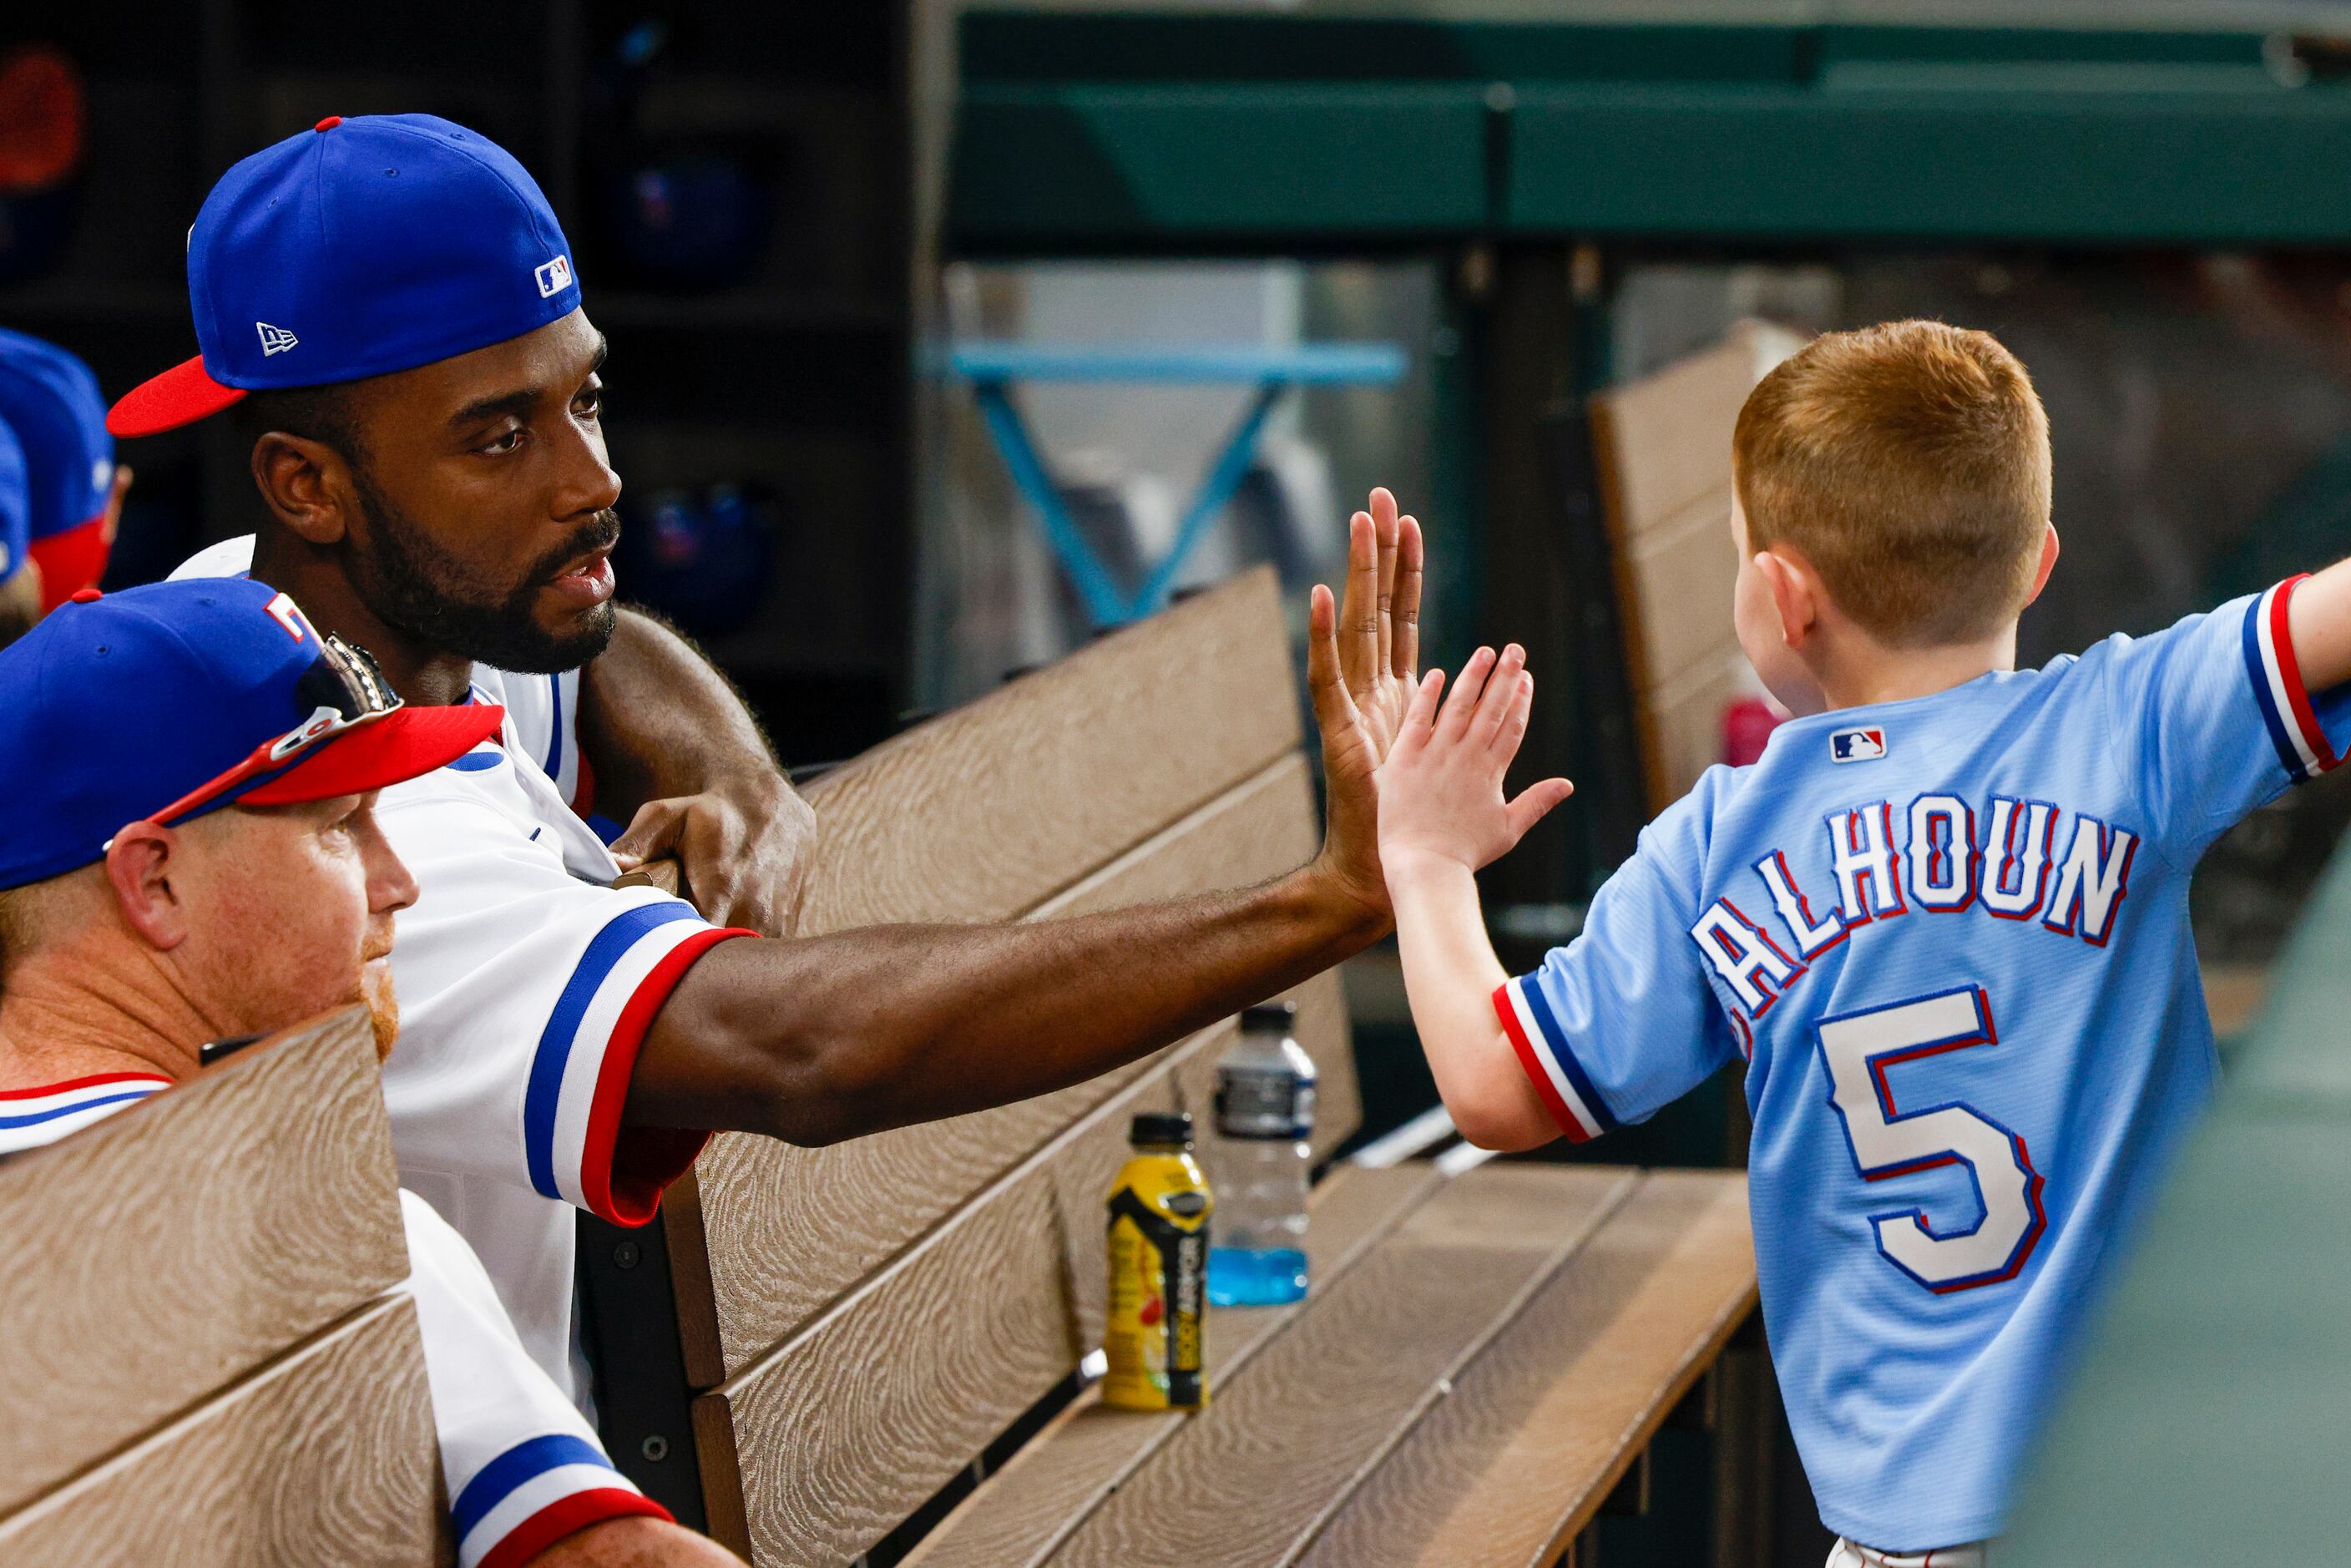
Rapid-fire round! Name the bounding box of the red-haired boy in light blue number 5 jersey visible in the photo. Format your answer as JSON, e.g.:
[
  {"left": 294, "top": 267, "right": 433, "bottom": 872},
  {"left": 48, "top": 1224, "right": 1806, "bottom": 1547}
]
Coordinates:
[{"left": 1380, "top": 322, "right": 2351, "bottom": 1568}]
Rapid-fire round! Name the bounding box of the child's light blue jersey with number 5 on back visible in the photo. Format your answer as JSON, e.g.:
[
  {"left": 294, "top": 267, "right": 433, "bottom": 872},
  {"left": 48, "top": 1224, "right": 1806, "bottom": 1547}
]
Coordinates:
[{"left": 1495, "top": 583, "right": 2351, "bottom": 1551}]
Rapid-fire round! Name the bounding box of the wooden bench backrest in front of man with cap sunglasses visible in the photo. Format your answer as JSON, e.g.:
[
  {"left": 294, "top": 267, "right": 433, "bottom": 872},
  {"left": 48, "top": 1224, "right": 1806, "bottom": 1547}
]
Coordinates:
[{"left": 0, "top": 1011, "right": 449, "bottom": 1568}]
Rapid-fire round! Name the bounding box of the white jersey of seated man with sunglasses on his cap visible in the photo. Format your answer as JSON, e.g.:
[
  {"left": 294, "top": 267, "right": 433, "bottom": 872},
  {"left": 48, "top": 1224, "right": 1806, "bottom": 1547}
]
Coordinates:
[{"left": 0, "top": 1072, "right": 670, "bottom": 1568}]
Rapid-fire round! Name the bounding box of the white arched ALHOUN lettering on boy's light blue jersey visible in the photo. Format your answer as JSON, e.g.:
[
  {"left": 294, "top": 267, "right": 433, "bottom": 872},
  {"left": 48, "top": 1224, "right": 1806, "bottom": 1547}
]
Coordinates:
[{"left": 1691, "top": 795, "right": 2140, "bottom": 1018}]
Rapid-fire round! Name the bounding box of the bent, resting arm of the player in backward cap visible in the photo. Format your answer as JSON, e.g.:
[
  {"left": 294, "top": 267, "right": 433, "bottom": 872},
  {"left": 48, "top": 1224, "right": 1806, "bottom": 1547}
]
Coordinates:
[{"left": 581, "top": 609, "right": 816, "bottom": 936}]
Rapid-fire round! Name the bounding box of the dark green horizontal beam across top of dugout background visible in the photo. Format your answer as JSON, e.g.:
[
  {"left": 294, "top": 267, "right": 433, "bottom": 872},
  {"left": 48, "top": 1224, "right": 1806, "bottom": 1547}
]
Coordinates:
[{"left": 948, "top": 0, "right": 2351, "bottom": 256}]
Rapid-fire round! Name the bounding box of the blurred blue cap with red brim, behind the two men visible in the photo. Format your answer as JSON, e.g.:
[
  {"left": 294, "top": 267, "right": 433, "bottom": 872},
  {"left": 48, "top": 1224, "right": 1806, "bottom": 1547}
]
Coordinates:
[{"left": 0, "top": 326, "right": 115, "bottom": 611}]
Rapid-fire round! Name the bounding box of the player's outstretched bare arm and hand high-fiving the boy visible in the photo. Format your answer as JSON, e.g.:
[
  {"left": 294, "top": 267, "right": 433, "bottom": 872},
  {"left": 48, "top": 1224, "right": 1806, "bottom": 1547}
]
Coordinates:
[{"left": 623, "top": 503, "right": 1418, "bottom": 1145}]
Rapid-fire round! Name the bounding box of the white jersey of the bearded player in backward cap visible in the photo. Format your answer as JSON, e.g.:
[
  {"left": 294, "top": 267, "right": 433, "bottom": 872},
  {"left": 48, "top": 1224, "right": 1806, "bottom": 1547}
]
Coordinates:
[{"left": 176, "top": 541, "right": 750, "bottom": 1406}]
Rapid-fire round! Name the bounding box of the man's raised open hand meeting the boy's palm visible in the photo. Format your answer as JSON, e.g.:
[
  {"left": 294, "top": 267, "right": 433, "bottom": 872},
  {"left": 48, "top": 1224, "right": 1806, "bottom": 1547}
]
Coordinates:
[{"left": 1307, "top": 489, "right": 1423, "bottom": 919}]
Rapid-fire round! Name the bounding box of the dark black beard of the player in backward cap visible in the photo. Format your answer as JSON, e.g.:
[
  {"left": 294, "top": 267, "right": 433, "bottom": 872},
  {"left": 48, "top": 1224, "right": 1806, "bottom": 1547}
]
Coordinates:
[{"left": 351, "top": 456, "right": 620, "bottom": 675}]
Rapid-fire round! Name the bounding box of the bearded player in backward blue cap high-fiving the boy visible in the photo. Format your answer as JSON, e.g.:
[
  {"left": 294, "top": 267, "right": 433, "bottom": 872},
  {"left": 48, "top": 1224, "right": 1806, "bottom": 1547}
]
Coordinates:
[{"left": 110, "top": 115, "right": 1420, "bottom": 1399}]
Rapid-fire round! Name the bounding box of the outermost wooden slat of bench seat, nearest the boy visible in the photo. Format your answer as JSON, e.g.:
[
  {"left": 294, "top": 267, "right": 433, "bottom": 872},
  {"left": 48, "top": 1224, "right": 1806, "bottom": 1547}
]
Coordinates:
[{"left": 1305, "top": 1171, "right": 1757, "bottom": 1568}]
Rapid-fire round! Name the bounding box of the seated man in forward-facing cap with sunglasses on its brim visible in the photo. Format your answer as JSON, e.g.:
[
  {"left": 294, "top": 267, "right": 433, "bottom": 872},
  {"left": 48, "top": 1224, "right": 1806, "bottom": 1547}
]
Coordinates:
[{"left": 0, "top": 580, "right": 736, "bottom": 1568}]
